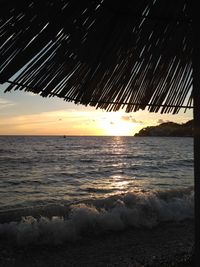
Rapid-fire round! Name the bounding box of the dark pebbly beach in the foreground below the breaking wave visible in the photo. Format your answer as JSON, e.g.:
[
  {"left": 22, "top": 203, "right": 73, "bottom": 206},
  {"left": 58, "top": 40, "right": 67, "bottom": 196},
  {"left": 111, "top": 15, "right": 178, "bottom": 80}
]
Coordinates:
[{"left": 0, "top": 221, "right": 194, "bottom": 267}]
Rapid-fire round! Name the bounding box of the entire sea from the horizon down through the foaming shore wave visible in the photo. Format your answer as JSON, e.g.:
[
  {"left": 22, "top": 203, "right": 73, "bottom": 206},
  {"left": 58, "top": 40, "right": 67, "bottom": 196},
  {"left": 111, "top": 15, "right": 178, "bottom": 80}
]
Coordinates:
[{"left": 0, "top": 136, "right": 194, "bottom": 244}]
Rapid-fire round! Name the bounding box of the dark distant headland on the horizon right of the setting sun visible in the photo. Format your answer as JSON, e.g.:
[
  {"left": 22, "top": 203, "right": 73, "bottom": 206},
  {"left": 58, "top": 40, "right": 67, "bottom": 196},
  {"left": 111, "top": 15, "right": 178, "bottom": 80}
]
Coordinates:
[{"left": 134, "top": 120, "right": 193, "bottom": 137}]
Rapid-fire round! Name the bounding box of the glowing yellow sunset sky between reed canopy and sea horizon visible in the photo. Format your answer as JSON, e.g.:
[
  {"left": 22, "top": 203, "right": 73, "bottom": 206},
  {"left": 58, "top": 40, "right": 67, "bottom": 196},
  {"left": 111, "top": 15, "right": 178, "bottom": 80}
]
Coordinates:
[{"left": 0, "top": 84, "right": 193, "bottom": 136}]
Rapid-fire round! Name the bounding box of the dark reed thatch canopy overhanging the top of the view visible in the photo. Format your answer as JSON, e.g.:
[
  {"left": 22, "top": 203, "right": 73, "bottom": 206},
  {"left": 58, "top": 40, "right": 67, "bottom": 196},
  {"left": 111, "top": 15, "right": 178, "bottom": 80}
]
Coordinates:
[{"left": 0, "top": 0, "right": 192, "bottom": 113}]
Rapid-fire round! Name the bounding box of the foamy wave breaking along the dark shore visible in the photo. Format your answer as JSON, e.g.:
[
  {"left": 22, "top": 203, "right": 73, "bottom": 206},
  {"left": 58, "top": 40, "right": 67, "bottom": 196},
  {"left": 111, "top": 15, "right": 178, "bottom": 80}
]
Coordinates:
[{"left": 0, "top": 188, "right": 194, "bottom": 245}]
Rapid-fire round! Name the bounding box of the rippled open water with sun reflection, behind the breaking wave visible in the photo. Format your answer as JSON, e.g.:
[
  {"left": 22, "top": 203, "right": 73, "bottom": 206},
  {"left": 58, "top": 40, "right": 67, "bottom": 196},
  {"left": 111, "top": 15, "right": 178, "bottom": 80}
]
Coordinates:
[{"left": 0, "top": 137, "right": 193, "bottom": 209}]
